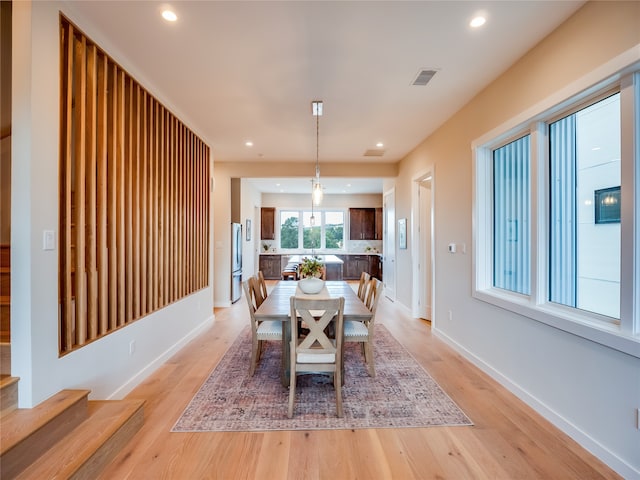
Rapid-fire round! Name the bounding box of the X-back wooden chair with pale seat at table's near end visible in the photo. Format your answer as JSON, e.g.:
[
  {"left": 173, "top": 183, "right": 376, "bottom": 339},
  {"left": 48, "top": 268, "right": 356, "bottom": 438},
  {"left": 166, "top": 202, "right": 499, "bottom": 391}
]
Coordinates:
[{"left": 288, "top": 297, "right": 344, "bottom": 418}]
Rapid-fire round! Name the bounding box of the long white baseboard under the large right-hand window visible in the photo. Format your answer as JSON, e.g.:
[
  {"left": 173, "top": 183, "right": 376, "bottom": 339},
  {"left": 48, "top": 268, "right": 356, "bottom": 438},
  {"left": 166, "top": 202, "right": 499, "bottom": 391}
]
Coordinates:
[{"left": 432, "top": 328, "right": 640, "bottom": 479}]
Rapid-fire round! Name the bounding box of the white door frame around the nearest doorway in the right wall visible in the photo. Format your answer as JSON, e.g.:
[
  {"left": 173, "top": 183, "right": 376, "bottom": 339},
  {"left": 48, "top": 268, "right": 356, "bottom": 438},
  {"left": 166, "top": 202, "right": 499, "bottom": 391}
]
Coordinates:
[{"left": 411, "top": 166, "right": 436, "bottom": 327}]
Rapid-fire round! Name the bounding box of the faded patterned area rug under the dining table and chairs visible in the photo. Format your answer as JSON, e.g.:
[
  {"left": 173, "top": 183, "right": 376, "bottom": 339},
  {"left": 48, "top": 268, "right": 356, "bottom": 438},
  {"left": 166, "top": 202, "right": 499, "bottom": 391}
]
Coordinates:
[{"left": 172, "top": 325, "right": 472, "bottom": 432}]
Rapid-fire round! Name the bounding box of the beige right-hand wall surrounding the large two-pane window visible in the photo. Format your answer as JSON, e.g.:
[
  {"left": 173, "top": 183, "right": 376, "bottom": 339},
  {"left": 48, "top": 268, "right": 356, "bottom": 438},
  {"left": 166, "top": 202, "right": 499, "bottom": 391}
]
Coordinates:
[{"left": 395, "top": 2, "right": 640, "bottom": 478}]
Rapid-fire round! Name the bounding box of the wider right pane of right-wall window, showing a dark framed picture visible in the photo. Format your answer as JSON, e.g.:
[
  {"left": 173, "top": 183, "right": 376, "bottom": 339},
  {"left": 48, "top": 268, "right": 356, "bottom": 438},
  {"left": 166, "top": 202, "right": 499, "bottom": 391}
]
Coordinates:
[{"left": 549, "top": 94, "right": 621, "bottom": 318}]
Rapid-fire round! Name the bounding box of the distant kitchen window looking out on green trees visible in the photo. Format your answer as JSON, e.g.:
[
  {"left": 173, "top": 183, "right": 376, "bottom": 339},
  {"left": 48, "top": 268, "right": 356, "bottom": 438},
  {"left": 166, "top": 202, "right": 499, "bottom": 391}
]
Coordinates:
[{"left": 280, "top": 210, "right": 344, "bottom": 251}]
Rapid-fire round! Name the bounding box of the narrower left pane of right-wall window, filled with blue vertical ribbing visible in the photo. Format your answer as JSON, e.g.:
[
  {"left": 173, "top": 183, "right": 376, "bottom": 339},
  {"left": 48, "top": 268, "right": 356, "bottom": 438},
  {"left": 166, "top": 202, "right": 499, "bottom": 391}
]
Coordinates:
[{"left": 493, "top": 135, "right": 531, "bottom": 295}]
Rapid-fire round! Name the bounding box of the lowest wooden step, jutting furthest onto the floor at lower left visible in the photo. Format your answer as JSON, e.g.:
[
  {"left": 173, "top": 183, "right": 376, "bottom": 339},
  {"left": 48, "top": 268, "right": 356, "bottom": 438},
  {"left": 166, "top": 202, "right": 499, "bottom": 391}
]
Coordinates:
[{"left": 14, "top": 400, "right": 144, "bottom": 480}]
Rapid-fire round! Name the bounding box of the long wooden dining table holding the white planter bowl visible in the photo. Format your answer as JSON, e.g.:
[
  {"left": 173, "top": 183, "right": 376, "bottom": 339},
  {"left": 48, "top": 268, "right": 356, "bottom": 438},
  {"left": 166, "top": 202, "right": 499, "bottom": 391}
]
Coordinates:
[{"left": 255, "top": 280, "right": 372, "bottom": 387}]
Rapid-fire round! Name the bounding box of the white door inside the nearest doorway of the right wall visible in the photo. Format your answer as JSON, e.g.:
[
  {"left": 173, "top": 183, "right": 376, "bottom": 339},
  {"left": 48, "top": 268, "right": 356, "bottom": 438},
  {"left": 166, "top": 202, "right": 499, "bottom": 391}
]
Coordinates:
[{"left": 417, "top": 180, "right": 431, "bottom": 320}]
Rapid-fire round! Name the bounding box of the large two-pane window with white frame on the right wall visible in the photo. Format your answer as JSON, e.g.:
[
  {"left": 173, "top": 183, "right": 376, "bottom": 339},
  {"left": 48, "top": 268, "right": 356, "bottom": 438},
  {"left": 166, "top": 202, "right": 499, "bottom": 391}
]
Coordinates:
[{"left": 473, "top": 72, "right": 640, "bottom": 355}]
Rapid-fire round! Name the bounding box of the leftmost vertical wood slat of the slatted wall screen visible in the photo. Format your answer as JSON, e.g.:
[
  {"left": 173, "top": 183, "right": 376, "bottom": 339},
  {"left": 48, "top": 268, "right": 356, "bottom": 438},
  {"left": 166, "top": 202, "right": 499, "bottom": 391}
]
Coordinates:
[{"left": 60, "top": 24, "right": 73, "bottom": 352}]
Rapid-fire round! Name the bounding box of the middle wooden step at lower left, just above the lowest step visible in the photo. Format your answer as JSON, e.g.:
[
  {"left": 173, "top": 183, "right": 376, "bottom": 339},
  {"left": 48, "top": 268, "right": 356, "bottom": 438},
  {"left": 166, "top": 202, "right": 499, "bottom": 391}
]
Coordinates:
[{"left": 0, "top": 390, "right": 89, "bottom": 479}]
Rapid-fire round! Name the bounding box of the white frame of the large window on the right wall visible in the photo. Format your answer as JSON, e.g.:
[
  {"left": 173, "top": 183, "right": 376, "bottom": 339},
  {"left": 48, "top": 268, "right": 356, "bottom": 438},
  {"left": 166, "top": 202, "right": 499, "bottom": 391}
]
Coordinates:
[{"left": 472, "top": 61, "right": 640, "bottom": 358}]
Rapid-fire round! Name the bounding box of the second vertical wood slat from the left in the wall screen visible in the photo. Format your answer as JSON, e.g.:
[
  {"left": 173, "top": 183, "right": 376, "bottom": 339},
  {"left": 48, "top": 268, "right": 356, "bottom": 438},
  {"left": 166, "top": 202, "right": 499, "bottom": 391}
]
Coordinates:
[{"left": 71, "top": 32, "right": 87, "bottom": 345}]
